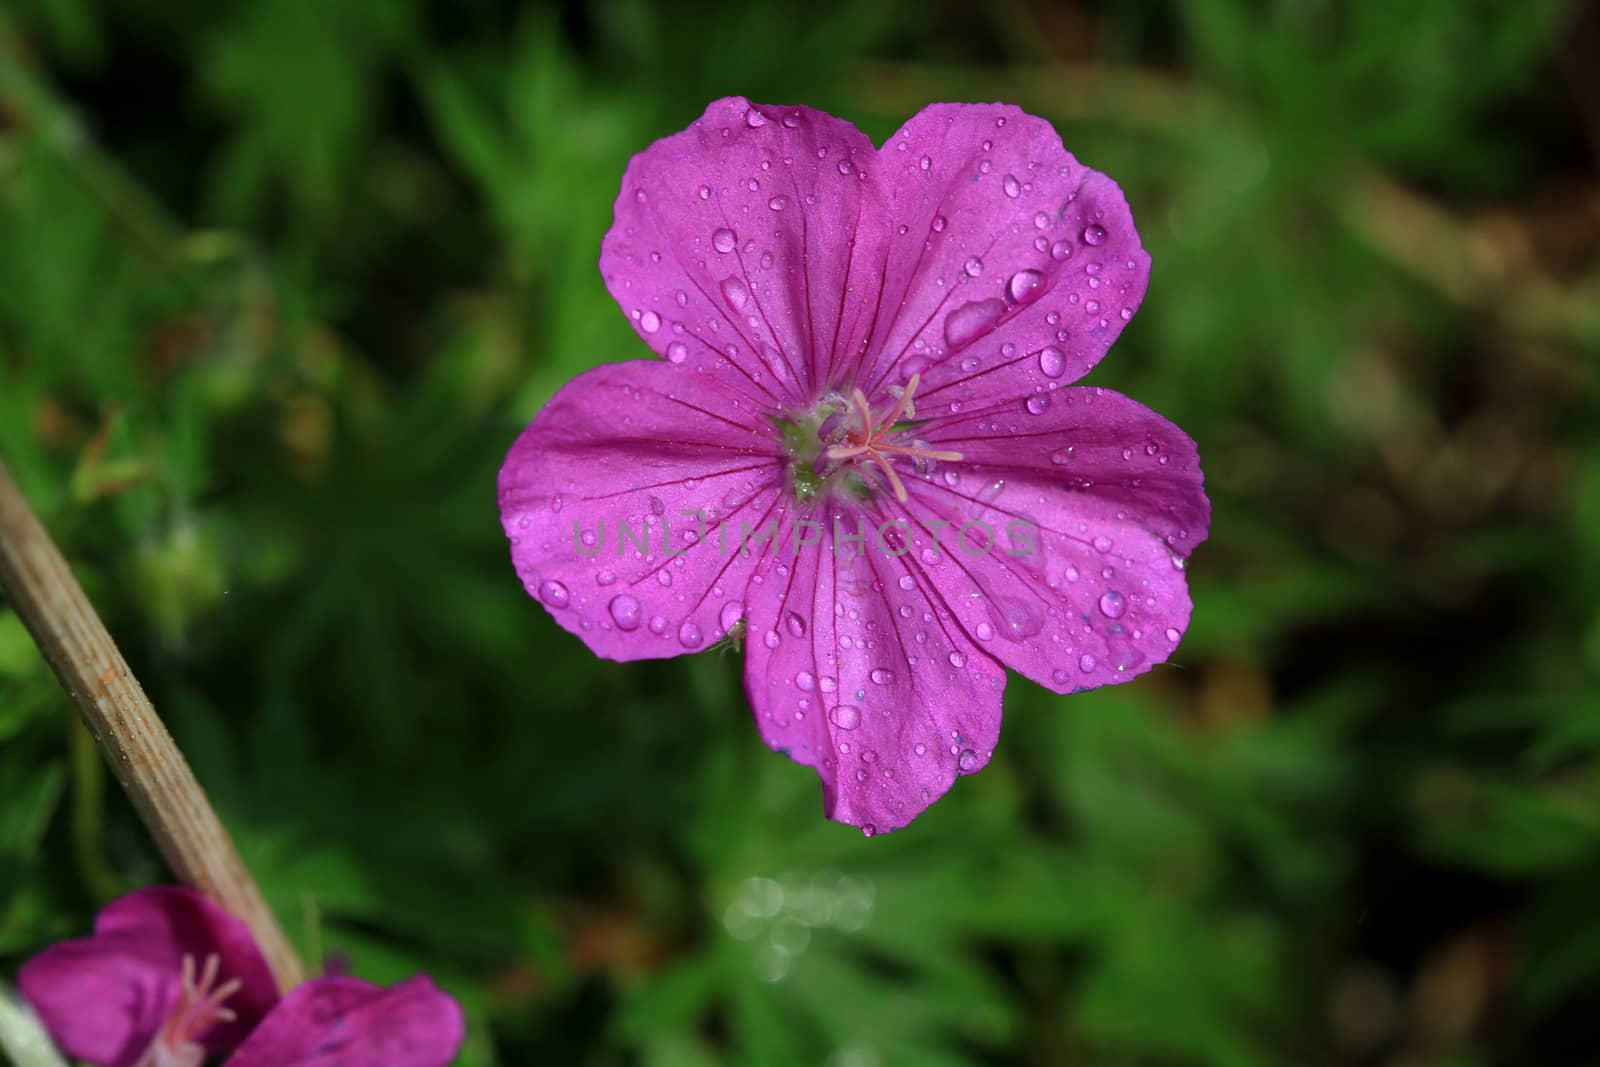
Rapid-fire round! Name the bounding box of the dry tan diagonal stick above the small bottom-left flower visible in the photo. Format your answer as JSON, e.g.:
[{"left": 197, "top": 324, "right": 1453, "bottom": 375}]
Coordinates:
[{"left": 0, "top": 462, "right": 302, "bottom": 992}]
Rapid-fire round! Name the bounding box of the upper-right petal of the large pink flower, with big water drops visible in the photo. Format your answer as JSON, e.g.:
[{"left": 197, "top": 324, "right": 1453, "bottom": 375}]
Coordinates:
[{"left": 864, "top": 104, "right": 1150, "bottom": 404}]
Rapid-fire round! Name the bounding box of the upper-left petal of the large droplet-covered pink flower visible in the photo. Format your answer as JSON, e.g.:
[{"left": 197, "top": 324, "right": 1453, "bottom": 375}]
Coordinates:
[{"left": 600, "top": 98, "right": 888, "bottom": 402}]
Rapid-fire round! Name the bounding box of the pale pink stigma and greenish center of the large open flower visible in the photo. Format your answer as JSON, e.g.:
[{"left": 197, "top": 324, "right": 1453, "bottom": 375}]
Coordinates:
[{"left": 781, "top": 374, "right": 962, "bottom": 504}]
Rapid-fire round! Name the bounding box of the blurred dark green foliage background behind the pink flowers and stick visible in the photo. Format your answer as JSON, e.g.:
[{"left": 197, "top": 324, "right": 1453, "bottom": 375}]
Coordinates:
[{"left": 0, "top": 0, "right": 1600, "bottom": 1067}]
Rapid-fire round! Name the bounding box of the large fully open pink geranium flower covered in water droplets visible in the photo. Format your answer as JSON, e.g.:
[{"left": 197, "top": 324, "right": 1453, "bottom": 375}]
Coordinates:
[{"left": 499, "top": 98, "right": 1210, "bottom": 833}]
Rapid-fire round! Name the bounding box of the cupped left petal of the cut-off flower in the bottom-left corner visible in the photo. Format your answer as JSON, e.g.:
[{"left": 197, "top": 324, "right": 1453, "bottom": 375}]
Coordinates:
[{"left": 18, "top": 886, "right": 277, "bottom": 1067}]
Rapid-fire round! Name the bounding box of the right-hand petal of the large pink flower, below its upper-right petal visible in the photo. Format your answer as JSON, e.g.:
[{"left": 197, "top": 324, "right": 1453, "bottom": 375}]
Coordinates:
[{"left": 909, "top": 387, "right": 1211, "bottom": 693}]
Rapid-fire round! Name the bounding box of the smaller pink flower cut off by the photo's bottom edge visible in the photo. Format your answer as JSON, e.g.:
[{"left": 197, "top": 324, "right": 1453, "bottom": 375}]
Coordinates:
[{"left": 18, "top": 886, "right": 464, "bottom": 1067}]
